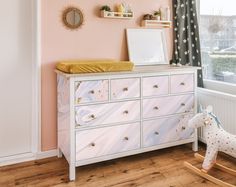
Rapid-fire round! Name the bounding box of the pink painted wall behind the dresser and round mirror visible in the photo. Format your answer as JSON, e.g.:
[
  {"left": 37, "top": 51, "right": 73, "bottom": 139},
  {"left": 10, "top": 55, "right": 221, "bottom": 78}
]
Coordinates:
[{"left": 41, "top": 0, "right": 172, "bottom": 151}]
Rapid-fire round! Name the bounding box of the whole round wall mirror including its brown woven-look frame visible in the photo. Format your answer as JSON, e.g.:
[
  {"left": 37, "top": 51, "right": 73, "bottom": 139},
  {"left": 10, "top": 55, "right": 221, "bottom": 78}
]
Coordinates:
[{"left": 62, "top": 7, "right": 84, "bottom": 29}]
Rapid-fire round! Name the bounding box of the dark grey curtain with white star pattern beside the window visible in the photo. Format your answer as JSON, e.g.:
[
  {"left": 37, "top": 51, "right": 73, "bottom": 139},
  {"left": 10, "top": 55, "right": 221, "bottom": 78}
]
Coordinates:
[{"left": 172, "top": 0, "right": 203, "bottom": 87}]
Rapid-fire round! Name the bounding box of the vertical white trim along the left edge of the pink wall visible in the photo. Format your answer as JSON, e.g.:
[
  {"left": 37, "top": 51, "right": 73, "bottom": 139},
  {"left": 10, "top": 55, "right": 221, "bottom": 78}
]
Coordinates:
[{"left": 31, "top": 0, "right": 41, "bottom": 154}]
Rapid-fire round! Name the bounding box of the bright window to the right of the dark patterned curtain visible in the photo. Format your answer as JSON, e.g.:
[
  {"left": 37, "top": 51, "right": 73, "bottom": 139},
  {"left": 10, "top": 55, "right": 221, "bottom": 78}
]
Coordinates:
[{"left": 199, "top": 0, "right": 236, "bottom": 84}]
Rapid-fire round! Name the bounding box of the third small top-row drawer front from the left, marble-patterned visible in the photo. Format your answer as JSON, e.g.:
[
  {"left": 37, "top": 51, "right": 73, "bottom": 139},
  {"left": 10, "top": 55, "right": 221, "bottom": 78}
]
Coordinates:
[{"left": 143, "top": 76, "right": 169, "bottom": 97}]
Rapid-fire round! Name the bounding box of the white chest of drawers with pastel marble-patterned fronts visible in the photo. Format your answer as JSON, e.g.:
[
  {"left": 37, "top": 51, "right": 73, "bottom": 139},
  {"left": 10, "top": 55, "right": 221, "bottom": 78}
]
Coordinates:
[{"left": 56, "top": 65, "right": 200, "bottom": 180}]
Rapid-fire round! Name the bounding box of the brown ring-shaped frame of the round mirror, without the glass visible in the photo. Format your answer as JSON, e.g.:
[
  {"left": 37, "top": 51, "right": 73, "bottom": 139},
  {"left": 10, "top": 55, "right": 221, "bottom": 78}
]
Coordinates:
[{"left": 62, "top": 7, "right": 84, "bottom": 30}]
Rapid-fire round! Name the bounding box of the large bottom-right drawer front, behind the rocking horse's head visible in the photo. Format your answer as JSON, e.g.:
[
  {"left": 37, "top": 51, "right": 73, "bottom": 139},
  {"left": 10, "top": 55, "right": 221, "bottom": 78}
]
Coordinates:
[{"left": 143, "top": 115, "right": 194, "bottom": 147}]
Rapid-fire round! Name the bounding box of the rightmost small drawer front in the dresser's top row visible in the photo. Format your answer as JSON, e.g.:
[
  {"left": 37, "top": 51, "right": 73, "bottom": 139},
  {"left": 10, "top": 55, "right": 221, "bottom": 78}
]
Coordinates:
[{"left": 171, "top": 74, "right": 194, "bottom": 94}]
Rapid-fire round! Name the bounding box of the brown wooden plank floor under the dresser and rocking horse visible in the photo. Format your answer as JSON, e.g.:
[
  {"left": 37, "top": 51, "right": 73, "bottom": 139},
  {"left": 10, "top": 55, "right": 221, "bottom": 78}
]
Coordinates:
[{"left": 0, "top": 145, "right": 236, "bottom": 187}]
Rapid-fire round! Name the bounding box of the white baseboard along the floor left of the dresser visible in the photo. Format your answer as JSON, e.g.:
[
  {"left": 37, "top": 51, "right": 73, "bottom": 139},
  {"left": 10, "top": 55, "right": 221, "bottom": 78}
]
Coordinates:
[{"left": 0, "top": 149, "right": 57, "bottom": 167}]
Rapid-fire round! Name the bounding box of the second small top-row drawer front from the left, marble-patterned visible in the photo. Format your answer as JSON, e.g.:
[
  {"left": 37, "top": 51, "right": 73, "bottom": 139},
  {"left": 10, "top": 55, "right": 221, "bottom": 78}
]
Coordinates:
[{"left": 111, "top": 78, "right": 140, "bottom": 100}]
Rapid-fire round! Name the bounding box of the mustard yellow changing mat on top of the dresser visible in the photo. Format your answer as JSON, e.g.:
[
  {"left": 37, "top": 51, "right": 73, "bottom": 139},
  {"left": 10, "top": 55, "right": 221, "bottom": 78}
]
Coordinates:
[{"left": 56, "top": 60, "right": 134, "bottom": 74}]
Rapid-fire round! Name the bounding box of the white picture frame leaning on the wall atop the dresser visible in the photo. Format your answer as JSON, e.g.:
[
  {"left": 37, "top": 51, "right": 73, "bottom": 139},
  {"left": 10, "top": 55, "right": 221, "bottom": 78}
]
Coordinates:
[{"left": 126, "top": 29, "right": 169, "bottom": 65}]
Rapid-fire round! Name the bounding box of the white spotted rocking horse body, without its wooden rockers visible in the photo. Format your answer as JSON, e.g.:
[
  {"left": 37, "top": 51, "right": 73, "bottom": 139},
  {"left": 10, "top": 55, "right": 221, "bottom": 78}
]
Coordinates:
[{"left": 188, "top": 106, "right": 236, "bottom": 172}]
